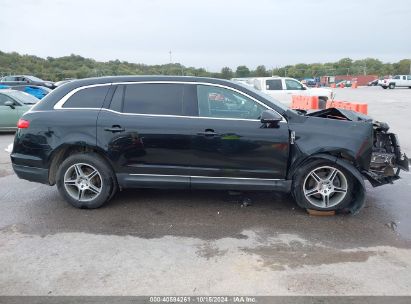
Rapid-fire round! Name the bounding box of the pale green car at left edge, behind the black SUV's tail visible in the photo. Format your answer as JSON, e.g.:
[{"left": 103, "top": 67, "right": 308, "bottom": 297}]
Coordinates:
[{"left": 0, "top": 89, "right": 39, "bottom": 131}]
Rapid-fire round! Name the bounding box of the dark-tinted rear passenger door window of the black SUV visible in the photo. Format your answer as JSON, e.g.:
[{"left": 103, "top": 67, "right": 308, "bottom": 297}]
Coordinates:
[{"left": 123, "top": 83, "right": 183, "bottom": 115}]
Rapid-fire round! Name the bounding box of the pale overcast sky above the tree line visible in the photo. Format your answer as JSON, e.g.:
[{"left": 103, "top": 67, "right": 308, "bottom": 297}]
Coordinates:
[{"left": 0, "top": 0, "right": 411, "bottom": 71}]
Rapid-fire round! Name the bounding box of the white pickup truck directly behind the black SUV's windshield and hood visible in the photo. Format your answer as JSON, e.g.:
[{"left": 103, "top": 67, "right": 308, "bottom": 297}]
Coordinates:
[{"left": 231, "top": 76, "right": 334, "bottom": 106}]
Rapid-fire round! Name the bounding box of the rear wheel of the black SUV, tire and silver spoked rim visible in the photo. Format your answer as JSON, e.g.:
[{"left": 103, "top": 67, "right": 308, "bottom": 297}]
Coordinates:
[{"left": 56, "top": 153, "right": 117, "bottom": 209}]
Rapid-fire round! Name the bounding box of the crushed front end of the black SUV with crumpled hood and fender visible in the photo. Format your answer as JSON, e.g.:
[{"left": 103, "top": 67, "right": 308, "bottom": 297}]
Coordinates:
[{"left": 290, "top": 108, "right": 409, "bottom": 213}]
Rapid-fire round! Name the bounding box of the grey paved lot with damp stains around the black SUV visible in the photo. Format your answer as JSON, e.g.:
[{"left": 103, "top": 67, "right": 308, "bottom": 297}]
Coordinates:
[{"left": 0, "top": 87, "right": 411, "bottom": 295}]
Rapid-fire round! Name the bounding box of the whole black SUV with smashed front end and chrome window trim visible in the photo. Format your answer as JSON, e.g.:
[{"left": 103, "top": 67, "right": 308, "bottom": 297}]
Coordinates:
[{"left": 11, "top": 76, "right": 408, "bottom": 212}]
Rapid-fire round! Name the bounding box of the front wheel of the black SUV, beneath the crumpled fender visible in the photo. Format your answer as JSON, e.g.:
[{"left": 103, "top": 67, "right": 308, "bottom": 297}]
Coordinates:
[{"left": 292, "top": 159, "right": 354, "bottom": 211}]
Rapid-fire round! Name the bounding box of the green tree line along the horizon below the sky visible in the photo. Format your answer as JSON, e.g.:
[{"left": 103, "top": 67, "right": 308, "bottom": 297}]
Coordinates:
[{"left": 0, "top": 51, "right": 411, "bottom": 81}]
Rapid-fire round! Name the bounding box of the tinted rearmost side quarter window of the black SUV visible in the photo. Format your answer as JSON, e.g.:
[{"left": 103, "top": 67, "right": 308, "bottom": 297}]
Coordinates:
[{"left": 63, "top": 85, "right": 110, "bottom": 109}]
